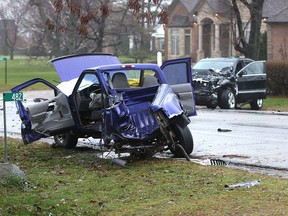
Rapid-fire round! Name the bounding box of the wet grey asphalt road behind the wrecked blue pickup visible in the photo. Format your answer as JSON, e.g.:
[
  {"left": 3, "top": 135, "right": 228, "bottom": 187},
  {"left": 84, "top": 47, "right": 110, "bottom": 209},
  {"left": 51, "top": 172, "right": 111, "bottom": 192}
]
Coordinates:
[{"left": 0, "top": 91, "right": 288, "bottom": 176}]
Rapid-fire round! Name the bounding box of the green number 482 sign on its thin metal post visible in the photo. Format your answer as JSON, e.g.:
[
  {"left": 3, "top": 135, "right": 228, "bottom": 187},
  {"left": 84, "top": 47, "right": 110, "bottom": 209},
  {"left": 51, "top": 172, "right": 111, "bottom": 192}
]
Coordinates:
[{"left": 3, "top": 92, "right": 23, "bottom": 162}]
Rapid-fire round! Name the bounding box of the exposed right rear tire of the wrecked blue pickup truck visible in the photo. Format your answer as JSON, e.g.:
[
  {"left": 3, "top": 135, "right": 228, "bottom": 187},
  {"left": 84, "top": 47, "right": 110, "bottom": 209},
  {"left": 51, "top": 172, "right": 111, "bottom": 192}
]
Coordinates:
[{"left": 169, "top": 124, "right": 194, "bottom": 157}]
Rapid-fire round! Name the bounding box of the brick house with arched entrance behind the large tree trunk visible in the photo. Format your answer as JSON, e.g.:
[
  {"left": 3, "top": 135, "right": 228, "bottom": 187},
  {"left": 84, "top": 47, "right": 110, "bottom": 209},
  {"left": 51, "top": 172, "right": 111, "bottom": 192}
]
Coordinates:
[{"left": 165, "top": 0, "right": 288, "bottom": 62}]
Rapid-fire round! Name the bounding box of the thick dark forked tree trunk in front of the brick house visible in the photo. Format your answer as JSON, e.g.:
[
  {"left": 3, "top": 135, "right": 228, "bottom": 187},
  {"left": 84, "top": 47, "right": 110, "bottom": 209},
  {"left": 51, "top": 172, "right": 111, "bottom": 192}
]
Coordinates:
[{"left": 231, "top": 0, "right": 264, "bottom": 59}]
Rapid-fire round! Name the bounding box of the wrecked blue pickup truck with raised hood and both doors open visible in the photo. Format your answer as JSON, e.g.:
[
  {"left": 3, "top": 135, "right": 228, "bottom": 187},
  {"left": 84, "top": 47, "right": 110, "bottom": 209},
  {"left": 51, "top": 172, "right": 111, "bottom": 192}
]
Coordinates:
[{"left": 12, "top": 54, "right": 196, "bottom": 157}]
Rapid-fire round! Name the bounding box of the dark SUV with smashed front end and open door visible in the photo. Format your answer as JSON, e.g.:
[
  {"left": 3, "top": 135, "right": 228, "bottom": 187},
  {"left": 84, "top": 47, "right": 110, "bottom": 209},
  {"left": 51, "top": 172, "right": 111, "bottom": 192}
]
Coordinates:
[{"left": 192, "top": 58, "right": 266, "bottom": 110}]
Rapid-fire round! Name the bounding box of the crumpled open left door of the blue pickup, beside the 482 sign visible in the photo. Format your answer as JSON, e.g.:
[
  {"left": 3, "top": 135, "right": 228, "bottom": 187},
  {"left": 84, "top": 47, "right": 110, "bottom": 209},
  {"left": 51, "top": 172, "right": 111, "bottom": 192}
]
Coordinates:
[{"left": 11, "top": 78, "right": 74, "bottom": 144}]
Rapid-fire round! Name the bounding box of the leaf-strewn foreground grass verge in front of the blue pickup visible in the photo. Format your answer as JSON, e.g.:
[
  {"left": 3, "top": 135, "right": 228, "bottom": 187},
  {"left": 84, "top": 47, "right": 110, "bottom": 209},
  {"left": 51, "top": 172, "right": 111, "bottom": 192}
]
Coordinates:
[{"left": 0, "top": 138, "right": 288, "bottom": 215}]
